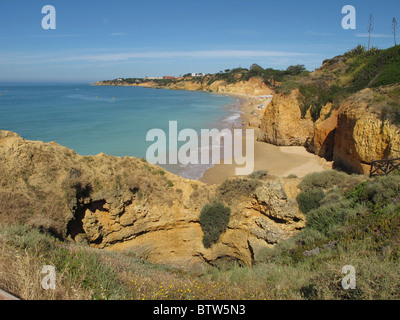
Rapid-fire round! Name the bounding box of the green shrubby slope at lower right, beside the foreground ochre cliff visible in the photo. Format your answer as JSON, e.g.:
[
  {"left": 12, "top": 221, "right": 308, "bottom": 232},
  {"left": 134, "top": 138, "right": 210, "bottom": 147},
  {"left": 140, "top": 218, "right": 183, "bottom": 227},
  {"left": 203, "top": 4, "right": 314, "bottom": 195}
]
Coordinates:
[{"left": 257, "top": 171, "right": 400, "bottom": 300}]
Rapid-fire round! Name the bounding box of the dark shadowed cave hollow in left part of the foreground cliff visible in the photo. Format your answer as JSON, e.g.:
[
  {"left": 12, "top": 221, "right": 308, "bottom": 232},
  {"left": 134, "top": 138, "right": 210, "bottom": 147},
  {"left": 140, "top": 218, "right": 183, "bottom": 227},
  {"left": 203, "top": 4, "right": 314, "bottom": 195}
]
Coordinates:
[{"left": 67, "top": 200, "right": 108, "bottom": 244}]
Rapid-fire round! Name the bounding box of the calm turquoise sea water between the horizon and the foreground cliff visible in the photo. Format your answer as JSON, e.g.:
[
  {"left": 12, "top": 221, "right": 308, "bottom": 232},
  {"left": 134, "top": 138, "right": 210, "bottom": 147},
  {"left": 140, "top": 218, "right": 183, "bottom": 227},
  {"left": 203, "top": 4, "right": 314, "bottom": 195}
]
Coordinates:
[{"left": 0, "top": 85, "right": 240, "bottom": 179}]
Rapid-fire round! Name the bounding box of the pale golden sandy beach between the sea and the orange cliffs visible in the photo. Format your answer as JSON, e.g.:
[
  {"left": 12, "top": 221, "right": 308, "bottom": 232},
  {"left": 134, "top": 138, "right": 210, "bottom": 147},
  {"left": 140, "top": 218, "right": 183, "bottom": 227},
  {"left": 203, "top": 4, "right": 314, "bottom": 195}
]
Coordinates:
[{"left": 200, "top": 94, "right": 332, "bottom": 184}]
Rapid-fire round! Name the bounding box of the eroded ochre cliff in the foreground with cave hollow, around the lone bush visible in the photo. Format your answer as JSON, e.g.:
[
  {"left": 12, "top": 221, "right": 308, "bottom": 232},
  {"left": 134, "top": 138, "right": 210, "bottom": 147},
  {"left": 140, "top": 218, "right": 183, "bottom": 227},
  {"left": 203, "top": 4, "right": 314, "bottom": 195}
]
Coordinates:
[{"left": 0, "top": 131, "right": 305, "bottom": 270}]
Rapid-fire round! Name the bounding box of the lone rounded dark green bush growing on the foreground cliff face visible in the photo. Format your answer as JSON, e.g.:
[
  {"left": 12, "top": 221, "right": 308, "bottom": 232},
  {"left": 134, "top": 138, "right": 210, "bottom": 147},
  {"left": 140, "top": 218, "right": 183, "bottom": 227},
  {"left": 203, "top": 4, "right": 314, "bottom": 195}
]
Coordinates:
[{"left": 200, "top": 202, "right": 231, "bottom": 248}]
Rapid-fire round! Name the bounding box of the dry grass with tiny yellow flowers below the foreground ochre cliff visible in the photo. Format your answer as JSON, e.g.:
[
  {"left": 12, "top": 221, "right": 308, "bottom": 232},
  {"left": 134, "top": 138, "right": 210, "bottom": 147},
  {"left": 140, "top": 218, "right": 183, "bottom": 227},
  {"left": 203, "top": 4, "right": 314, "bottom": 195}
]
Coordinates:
[{"left": 0, "top": 222, "right": 306, "bottom": 300}]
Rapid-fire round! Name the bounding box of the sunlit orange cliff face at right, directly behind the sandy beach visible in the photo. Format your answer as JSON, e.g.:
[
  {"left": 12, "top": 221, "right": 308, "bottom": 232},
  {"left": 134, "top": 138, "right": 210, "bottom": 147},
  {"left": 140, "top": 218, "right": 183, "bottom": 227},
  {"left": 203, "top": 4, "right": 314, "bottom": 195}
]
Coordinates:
[{"left": 259, "top": 89, "right": 400, "bottom": 173}]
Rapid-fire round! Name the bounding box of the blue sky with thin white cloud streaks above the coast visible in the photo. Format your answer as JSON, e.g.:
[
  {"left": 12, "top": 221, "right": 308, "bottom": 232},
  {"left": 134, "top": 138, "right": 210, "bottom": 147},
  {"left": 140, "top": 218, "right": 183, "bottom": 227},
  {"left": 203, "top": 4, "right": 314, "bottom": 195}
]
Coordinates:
[{"left": 0, "top": 0, "right": 400, "bottom": 83}]
